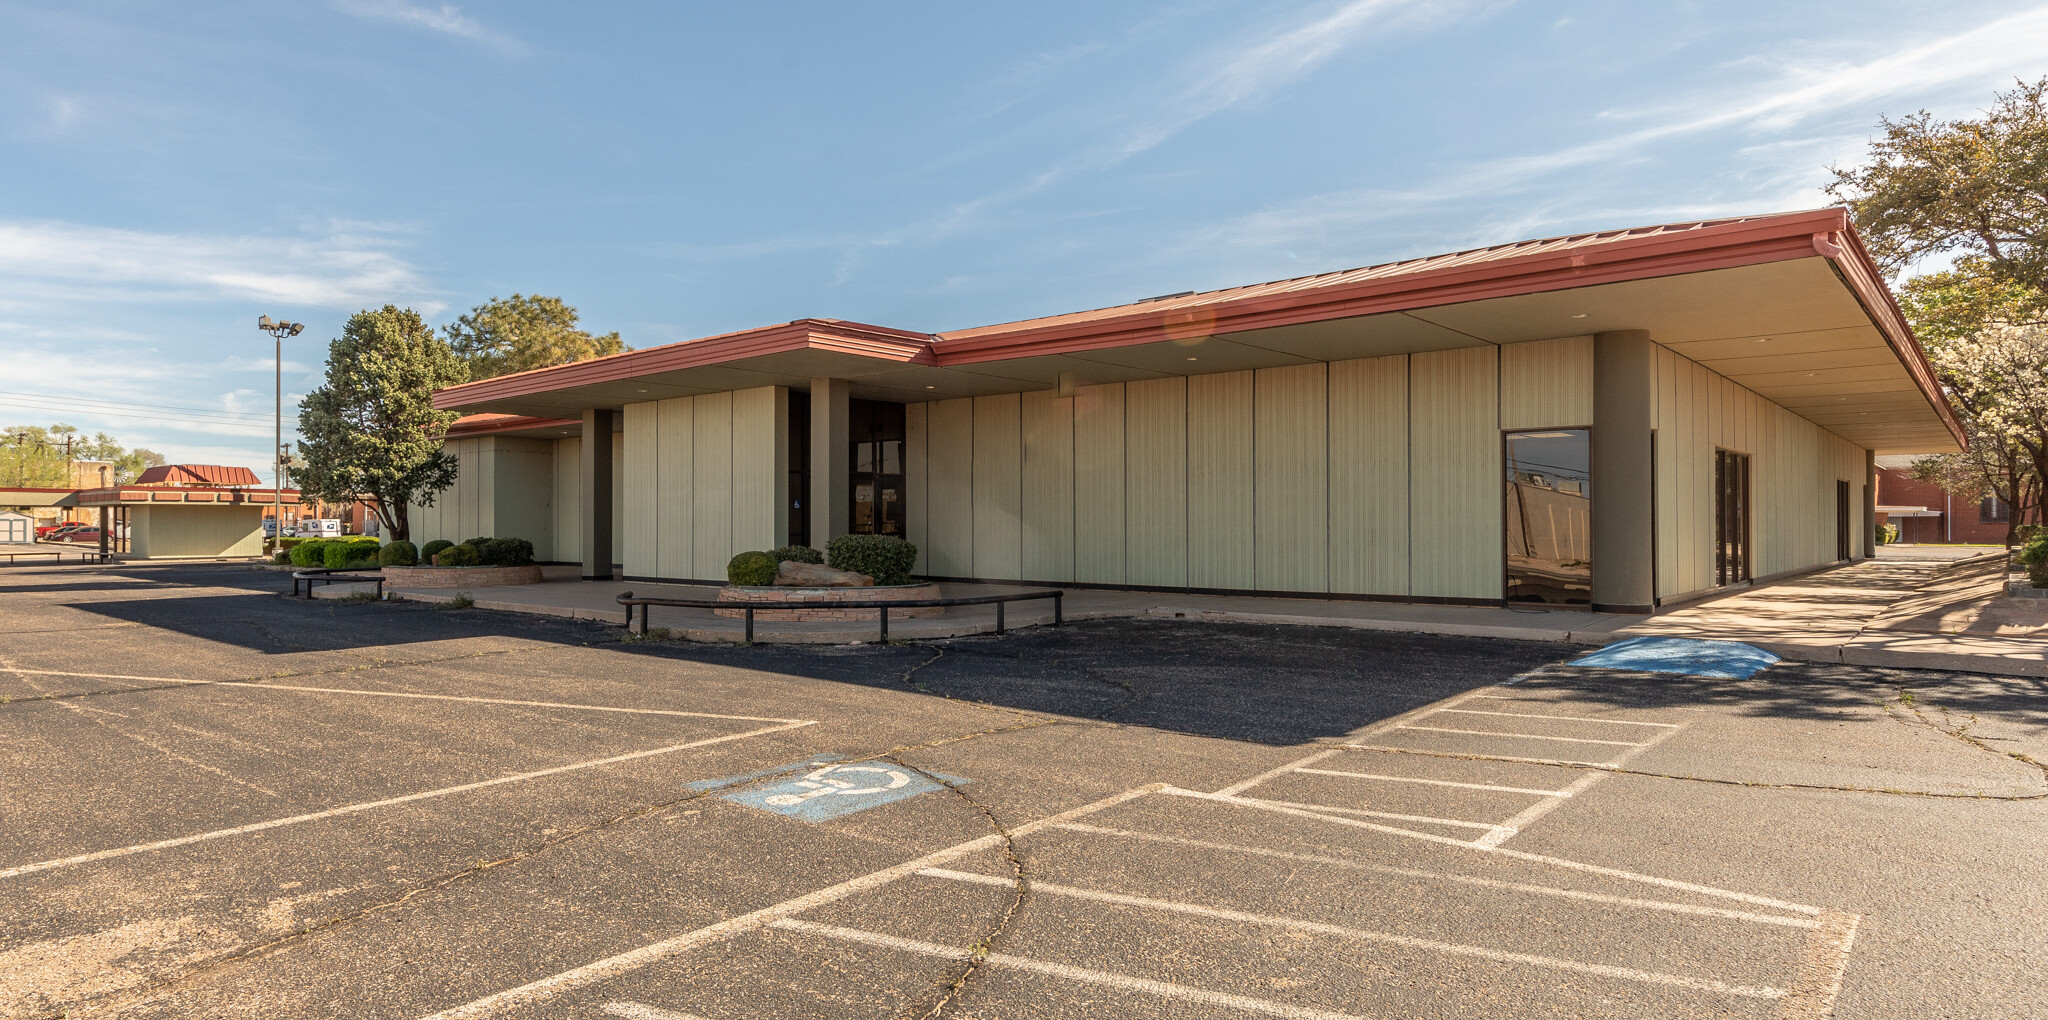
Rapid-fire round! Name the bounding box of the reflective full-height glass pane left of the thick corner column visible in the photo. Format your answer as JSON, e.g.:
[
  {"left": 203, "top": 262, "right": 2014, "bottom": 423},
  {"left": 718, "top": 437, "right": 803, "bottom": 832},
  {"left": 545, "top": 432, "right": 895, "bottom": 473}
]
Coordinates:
[{"left": 1501, "top": 428, "right": 1593, "bottom": 606}]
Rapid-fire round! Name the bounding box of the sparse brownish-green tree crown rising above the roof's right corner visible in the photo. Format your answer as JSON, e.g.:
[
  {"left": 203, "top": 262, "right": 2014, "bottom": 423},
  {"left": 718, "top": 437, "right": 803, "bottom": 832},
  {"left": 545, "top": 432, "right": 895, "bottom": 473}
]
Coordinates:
[{"left": 1827, "top": 78, "right": 2048, "bottom": 313}]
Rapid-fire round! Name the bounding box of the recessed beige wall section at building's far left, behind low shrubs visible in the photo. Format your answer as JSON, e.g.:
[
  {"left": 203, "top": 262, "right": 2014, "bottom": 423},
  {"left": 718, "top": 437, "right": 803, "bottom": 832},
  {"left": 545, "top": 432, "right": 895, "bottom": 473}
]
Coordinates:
[{"left": 406, "top": 436, "right": 575, "bottom": 561}]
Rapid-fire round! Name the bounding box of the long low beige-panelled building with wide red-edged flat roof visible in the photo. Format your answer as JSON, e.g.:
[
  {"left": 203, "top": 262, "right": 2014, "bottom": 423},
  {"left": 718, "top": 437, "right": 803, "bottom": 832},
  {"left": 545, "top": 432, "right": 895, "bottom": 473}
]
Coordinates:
[{"left": 412, "top": 209, "right": 1962, "bottom": 612}]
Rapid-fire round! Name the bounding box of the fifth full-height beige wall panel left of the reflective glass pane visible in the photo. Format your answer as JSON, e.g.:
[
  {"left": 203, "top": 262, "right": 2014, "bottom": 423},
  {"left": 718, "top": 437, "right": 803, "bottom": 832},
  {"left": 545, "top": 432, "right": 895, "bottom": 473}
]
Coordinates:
[{"left": 1124, "top": 377, "right": 1188, "bottom": 588}]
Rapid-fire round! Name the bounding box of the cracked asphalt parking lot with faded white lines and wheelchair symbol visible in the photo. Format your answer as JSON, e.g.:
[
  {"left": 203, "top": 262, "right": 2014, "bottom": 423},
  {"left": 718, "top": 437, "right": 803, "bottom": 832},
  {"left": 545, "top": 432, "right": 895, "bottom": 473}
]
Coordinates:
[{"left": 0, "top": 567, "right": 2048, "bottom": 1020}]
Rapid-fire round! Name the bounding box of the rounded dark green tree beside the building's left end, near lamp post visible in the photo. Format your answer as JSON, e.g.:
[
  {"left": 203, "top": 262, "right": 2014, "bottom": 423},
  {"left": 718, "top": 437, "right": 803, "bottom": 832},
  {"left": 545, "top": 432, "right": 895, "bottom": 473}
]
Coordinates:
[{"left": 299, "top": 305, "right": 465, "bottom": 541}]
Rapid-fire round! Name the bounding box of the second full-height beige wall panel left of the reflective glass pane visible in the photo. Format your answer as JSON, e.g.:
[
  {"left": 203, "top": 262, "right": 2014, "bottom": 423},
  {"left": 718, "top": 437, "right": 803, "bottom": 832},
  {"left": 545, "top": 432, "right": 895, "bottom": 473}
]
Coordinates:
[{"left": 1329, "top": 354, "right": 1409, "bottom": 596}]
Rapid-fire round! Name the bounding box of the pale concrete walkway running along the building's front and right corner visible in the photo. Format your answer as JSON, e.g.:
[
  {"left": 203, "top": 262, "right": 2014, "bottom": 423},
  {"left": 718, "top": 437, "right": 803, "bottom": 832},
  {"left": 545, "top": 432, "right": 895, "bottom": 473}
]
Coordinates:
[{"left": 344, "top": 553, "right": 2048, "bottom": 676}]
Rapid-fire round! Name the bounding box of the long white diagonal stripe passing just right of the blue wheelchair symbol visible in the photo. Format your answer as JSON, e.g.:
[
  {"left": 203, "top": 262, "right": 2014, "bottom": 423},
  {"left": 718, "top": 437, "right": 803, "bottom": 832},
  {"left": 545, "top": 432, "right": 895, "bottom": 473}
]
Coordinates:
[{"left": 407, "top": 787, "right": 1159, "bottom": 1020}]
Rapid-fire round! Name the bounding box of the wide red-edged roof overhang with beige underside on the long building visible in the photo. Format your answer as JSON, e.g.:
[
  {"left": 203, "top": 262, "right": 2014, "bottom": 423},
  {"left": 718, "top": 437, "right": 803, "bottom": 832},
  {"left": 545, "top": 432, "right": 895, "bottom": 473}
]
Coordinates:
[{"left": 434, "top": 209, "right": 1964, "bottom": 453}]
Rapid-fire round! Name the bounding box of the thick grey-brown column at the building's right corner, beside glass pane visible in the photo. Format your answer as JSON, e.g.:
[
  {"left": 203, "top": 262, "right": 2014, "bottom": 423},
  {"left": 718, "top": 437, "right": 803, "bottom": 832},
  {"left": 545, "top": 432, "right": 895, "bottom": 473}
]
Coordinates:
[{"left": 1591, "top": 330, "right": 1657, "bottom": 612}]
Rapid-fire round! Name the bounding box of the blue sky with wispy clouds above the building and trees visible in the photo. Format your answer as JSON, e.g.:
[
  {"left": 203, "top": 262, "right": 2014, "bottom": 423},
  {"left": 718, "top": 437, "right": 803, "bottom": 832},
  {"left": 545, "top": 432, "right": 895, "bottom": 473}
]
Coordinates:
[{"left": 0, "top": 0, "right": 2048, "bottom": 467}]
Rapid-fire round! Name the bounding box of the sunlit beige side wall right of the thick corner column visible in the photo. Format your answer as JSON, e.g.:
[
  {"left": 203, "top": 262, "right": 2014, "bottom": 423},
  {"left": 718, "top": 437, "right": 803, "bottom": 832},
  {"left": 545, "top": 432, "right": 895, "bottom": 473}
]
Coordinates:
[{"left": 1657, "top": 350, "right": 1866, "bottom": 598}]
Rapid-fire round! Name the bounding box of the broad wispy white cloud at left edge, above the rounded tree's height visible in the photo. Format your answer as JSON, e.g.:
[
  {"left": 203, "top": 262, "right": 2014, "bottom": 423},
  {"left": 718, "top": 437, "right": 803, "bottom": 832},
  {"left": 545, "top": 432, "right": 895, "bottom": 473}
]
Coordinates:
[{"left": 0, "top": 221, "right": 440, "bottom": 311}]
